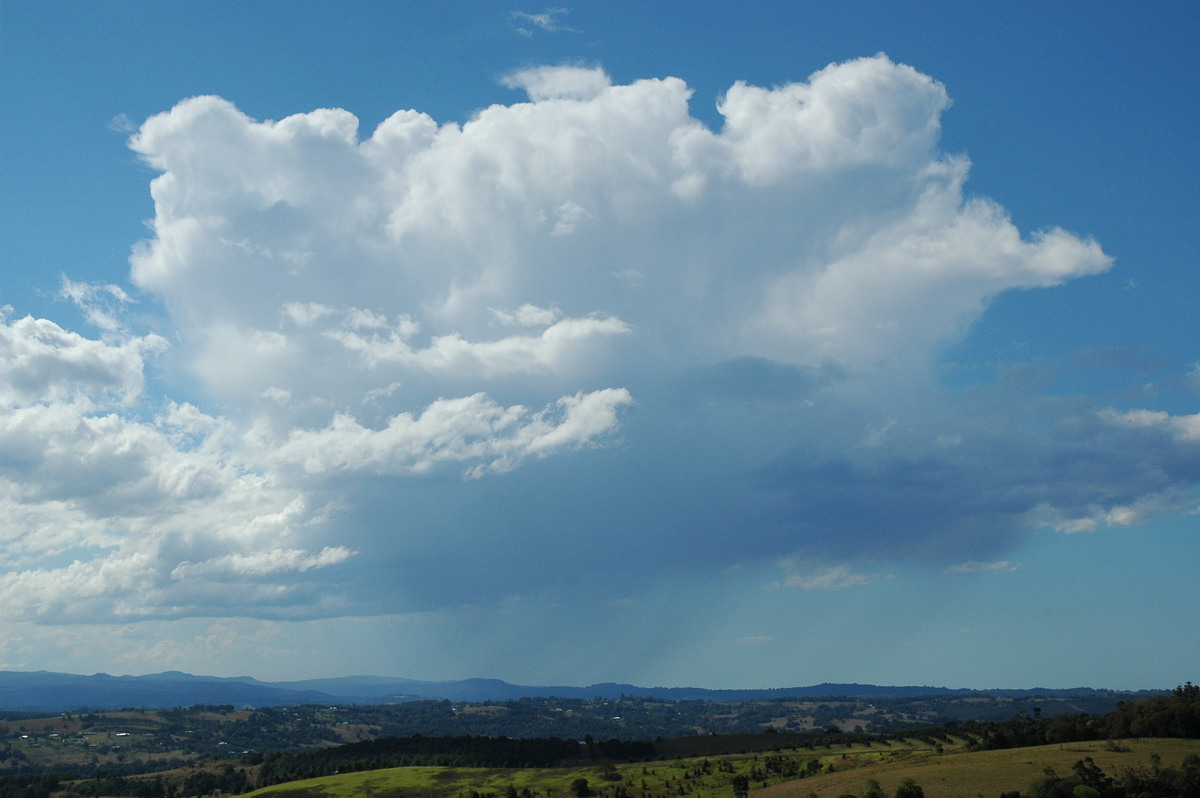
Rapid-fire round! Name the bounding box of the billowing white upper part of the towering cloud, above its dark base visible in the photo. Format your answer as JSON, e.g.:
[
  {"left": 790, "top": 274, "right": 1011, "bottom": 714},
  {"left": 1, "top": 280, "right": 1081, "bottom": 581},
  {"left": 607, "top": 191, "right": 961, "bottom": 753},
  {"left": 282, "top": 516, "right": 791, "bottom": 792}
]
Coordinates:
[{"left": 124, "top": 56, "right": 1110, "bottom": 417}]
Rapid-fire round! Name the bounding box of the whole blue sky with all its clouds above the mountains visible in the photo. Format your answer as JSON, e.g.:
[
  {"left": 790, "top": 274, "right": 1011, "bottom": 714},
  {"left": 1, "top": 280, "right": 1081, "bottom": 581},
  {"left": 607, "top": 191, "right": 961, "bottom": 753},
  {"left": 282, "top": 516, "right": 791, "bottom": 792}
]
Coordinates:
[{"left": 0, "top": 0, "right": 1200, "bottom": 689}]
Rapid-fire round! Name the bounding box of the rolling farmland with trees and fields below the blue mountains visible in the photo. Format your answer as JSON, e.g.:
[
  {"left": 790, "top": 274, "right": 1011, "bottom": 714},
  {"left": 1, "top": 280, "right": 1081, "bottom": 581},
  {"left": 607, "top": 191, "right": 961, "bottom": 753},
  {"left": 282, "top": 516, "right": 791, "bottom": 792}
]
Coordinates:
[{"left": 0, "top": 683, "right": 1200, "bottom": 798}]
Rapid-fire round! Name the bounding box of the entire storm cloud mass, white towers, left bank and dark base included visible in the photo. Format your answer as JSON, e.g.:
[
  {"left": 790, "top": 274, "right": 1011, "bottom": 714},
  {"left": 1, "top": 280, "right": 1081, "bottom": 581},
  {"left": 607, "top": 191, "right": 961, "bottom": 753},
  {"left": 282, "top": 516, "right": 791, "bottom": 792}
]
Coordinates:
[{"left": 0, "top": 55, "right": 1196, "bottom": 633}]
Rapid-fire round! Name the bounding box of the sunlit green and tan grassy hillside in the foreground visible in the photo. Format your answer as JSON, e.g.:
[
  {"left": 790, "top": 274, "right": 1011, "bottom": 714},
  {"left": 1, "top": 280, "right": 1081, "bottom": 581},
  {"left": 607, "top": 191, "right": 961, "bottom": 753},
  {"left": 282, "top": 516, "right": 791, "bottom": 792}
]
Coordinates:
[{"left": 241, "top": 739, "right": 1200, "bottom": 798}]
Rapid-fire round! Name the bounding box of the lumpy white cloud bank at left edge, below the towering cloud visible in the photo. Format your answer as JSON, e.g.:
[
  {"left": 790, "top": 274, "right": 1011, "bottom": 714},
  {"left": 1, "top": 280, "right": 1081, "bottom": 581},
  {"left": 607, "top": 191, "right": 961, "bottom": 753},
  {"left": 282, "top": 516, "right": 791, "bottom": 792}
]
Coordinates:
[{"left": 0, "top": 304, "right": 360, "bottom": 623}]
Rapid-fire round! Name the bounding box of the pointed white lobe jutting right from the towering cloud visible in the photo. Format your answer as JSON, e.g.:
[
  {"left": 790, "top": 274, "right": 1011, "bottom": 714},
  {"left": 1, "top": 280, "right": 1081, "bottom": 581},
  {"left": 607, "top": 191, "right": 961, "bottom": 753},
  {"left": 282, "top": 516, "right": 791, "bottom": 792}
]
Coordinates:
[{"left": 746, "top": 178, "right": 1111, "bottom": 368}]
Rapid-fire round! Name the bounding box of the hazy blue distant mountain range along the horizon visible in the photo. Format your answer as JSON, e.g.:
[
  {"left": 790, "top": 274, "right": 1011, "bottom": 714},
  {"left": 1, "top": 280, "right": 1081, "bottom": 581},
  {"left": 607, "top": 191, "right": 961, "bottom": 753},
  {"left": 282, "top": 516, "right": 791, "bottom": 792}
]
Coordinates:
[{"left": 0, "top": 671, "right": 1157, "bottom": 712}]
